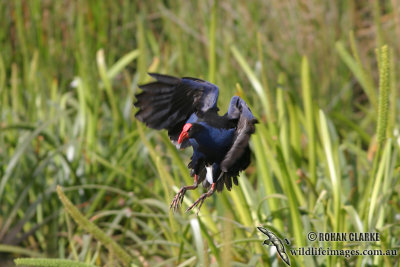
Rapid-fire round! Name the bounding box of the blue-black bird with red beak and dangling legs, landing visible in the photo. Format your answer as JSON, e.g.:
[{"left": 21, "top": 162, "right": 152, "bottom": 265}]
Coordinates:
[{"left": 134, "top": 73, "right": 257, "bottom": 216}]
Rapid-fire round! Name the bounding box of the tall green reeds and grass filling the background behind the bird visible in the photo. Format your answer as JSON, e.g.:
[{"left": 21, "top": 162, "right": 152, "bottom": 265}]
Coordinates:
[{"left": 0, "top": 0, "right": 400, "bottom": 266}]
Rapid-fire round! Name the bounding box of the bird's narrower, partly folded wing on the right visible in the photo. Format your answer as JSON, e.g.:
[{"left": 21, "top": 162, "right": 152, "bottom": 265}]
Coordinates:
[{"left": 221, "top": 96, "right": 257, "bottom": 172}]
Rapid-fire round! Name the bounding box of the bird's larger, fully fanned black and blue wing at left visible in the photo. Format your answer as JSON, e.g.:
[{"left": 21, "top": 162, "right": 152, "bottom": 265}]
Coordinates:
[{"left": 134, "top": 73, "right": 219, "bottom": 148}]
